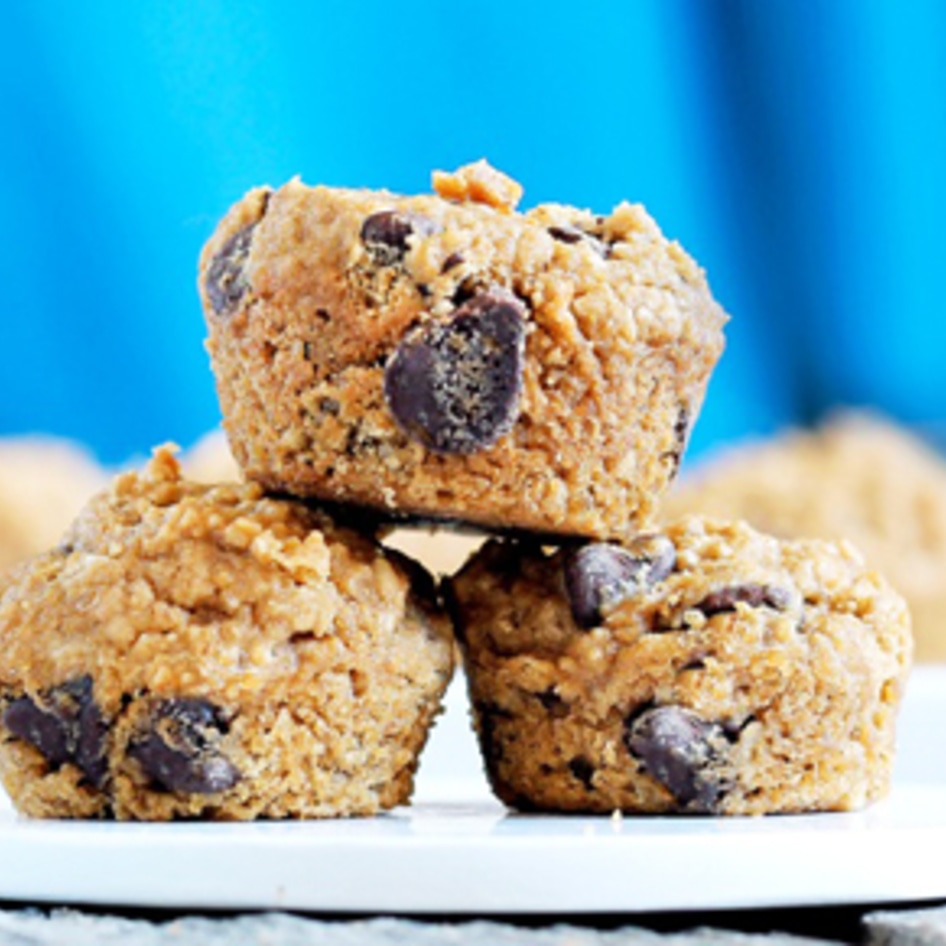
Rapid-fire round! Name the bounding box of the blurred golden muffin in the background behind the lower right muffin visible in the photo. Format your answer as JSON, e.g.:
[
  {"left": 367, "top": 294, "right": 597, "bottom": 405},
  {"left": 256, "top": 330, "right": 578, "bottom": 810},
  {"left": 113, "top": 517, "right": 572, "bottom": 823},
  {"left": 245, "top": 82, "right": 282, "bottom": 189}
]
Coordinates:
[{"left": 661, "top": 411, "right": 946, "bottom": 662}]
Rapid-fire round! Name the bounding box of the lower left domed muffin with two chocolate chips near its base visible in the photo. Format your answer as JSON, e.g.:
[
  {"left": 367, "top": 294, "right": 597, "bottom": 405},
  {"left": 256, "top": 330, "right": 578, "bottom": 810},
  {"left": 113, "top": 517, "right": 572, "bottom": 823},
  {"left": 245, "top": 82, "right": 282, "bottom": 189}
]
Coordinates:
[{"left": 0, "top": 449, "right": 453, "bottom": 820}]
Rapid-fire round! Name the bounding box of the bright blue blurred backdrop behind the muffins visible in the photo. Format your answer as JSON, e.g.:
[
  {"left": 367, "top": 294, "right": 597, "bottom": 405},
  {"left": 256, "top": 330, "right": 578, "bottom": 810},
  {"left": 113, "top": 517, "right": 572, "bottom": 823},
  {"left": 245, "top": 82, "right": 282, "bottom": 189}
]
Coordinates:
[{"left": 0, "top": 0, "right": 946, "bottom": 462}]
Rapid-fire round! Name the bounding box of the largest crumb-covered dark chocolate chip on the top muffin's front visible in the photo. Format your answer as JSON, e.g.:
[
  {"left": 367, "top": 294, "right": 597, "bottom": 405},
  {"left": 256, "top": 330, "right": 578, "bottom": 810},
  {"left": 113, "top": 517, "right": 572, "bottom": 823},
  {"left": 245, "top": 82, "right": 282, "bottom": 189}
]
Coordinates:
[{"left": 384, "top": 291, "right": 525, "bottom": 454}]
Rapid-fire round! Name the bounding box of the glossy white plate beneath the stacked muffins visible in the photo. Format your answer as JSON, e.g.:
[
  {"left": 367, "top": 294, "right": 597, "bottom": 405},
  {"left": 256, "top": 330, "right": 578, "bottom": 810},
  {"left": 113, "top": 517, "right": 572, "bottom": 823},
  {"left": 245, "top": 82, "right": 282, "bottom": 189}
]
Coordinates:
[{"left": 0, "top": 668, "right": 946, "bottom": 914}]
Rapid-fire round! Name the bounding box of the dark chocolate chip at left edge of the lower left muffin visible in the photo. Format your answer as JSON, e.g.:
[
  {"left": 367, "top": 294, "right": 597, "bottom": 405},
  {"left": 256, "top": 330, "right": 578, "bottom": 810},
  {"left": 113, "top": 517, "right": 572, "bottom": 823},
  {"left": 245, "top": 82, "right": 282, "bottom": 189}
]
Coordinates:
[{"left": 3, "top": 675, "right": 108, "bottom": 787}]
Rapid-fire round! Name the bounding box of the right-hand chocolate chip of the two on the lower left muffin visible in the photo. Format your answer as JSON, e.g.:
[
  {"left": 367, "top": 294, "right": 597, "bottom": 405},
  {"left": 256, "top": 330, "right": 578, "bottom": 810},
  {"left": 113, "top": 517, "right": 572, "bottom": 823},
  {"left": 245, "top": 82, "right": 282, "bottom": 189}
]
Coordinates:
[{"left": 128, "top": 697, "right": 240, "bottom": 795}]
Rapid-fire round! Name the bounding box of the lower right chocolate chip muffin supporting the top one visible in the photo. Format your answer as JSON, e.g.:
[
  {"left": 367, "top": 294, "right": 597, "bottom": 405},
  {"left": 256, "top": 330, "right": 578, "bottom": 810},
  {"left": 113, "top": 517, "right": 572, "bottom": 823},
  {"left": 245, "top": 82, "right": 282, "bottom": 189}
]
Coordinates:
[{"left": 446, "top": 517, "right": 911, "bottom": 815}]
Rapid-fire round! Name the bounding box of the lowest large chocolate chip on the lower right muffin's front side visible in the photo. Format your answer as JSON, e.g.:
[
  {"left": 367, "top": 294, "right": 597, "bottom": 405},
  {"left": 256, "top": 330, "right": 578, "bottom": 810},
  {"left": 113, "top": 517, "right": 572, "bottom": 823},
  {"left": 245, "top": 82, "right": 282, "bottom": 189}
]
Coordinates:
[{"left": 625, "top": 706, "right": 727, "bottom": 812}]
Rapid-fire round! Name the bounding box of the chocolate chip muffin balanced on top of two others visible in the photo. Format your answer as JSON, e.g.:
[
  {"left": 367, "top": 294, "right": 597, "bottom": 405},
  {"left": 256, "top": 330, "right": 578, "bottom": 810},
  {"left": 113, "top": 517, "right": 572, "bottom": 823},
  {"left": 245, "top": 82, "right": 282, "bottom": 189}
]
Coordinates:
[{"left": 200, "top": 162, "right": 725, "bottom": 538}]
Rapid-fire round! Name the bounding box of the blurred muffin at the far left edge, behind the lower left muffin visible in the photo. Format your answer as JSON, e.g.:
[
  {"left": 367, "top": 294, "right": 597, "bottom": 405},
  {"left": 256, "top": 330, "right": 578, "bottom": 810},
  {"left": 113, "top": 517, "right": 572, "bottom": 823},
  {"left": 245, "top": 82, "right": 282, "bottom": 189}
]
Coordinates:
[{"left": 0, "top": 435, "right": 108, "bottom": 573}]
